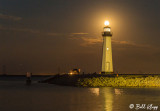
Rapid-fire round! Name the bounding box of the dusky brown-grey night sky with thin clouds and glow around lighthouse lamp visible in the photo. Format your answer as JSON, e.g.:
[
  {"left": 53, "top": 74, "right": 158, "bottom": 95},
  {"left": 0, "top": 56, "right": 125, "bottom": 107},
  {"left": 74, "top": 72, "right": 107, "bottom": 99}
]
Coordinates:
[{"left": 0, "top": 0, "right": 160, "bottom": 74}]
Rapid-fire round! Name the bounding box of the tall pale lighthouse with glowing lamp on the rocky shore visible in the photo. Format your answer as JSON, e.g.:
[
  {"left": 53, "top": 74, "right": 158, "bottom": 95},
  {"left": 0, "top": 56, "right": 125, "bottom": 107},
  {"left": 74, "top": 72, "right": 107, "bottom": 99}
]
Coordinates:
[{"left": 101, "top": 21, "right": 113, "bottom": 74}]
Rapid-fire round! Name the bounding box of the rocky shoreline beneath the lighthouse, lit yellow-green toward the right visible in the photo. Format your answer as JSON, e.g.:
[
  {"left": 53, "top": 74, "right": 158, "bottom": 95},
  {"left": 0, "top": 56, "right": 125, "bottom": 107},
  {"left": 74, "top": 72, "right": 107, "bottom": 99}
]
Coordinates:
[{"left": 39, "top": 74, "right": 160, "bottom": 87}]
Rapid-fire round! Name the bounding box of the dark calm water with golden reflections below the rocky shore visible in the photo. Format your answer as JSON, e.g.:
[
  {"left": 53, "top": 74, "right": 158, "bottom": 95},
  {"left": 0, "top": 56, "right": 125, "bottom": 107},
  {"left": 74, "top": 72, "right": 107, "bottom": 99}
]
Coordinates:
[{"left": 0, "top": 78, "right": 160, "bottom": 111}]
